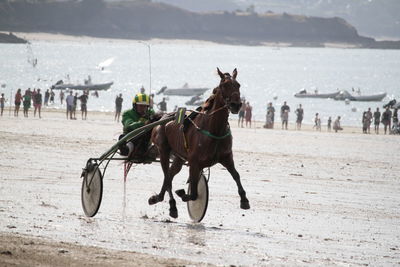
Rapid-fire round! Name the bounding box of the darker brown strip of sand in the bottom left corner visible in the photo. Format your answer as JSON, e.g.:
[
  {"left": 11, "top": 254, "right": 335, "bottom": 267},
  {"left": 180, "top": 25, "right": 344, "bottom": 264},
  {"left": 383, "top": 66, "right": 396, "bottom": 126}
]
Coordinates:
[{"left": 0, "top": 232, "right": 205, "bottom": 267}]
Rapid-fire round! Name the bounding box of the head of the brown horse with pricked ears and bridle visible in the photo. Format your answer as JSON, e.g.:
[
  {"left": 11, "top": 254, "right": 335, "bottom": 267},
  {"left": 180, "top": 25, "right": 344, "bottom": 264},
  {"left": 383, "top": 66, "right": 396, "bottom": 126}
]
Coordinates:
[{"left": 217, "top": 68, "right": 242, "bottom": 114}]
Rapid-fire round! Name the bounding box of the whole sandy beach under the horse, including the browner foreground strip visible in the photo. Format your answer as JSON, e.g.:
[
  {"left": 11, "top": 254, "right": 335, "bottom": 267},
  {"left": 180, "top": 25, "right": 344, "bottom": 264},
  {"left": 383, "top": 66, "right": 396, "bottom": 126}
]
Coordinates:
[{"left": 0, "top": 111, "right": 400, "bottom": 266}]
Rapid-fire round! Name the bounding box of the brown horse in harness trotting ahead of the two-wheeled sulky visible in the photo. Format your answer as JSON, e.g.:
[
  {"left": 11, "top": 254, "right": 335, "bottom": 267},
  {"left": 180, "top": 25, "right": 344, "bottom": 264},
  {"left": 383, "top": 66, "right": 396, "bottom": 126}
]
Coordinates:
[{"left": 149, "top": 68, "right": 250, "bottom": 218}]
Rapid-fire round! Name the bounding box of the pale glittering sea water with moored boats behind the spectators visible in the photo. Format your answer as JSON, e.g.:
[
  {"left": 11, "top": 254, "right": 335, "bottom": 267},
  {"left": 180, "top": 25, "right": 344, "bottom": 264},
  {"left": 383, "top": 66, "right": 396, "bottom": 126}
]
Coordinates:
[{"left": 0, "top": 39, "right": 400, "bottom": 126}]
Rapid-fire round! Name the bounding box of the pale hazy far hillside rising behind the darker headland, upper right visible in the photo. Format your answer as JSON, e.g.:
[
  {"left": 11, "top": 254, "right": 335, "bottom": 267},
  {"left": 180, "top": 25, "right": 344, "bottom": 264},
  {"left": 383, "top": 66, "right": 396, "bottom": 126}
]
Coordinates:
[{"left": 155, "top": 0, "right": 400, "bottom": 40}]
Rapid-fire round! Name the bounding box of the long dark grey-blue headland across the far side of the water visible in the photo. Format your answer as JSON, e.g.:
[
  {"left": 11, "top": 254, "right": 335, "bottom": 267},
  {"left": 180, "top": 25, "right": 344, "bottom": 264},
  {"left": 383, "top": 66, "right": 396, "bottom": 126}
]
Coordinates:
[{"left": 0, "top": 0, "right": 400, "bottom": 48}]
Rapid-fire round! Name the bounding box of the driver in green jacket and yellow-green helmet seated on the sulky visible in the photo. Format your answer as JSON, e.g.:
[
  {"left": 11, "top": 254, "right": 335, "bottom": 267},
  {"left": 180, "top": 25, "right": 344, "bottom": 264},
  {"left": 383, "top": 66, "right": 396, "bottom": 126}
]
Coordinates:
[{"left": 119, "top": 93, "right": 154, "bottom": 158}]
